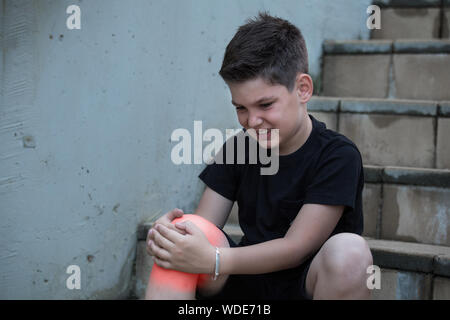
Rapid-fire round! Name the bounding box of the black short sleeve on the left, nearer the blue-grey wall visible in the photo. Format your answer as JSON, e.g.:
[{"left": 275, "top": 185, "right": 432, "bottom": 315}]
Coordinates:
[{"left": 198, "top": 137, "right": 239, "bottom": 201}]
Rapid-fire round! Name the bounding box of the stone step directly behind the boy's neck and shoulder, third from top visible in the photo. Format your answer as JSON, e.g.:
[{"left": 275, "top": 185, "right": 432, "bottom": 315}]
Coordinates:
[{"left": 307, "top": 96, "right": 450, "bottom": 169}]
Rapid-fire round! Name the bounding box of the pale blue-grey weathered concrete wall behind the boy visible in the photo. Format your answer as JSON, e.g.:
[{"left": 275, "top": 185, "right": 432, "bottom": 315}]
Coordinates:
[{"left": 0, "top": 0, "right": 370, "bottom": 299}]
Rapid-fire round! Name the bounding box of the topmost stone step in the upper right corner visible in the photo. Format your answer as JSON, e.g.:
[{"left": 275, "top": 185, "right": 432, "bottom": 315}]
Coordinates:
[{"left": 371, "top": 0, "right": 450, "bottom": 39}]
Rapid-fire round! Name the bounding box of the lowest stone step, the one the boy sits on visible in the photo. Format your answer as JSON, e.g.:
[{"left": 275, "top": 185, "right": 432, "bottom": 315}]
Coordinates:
[{"left": 132, "top": 223, "right": 450, "bottom": 300}]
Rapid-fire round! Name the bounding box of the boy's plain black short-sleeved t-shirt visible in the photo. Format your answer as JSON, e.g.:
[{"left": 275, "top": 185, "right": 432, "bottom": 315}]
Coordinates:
[{"left": 199, "top": 115, "right": 364, "bottom": 246}]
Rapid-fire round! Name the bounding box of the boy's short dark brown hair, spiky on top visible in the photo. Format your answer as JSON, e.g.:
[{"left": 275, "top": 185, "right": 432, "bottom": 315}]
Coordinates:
[{"left": 219, "top": 12, "right": 308, "bottom": 91}]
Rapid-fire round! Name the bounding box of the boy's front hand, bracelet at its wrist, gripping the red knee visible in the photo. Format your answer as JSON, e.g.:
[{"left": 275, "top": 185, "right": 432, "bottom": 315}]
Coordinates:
[{"left": 151, "top": 221, "right": 216, "bottom": 274}]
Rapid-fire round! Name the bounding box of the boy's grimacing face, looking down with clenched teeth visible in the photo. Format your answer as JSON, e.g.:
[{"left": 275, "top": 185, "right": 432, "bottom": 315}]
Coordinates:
[{"left": 228, "top": 78, "right": 309, "bottom": 155}]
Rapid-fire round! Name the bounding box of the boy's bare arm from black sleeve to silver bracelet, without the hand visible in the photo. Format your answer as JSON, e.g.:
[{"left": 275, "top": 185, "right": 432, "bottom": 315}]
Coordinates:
[{"left": 220, "top": 204, "right": 344, "bottom": 274}]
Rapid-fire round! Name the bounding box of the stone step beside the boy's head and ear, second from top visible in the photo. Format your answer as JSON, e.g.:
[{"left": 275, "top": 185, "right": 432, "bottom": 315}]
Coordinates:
[{"left": 321, "top": 39, "right": 450, "bottom": 101}]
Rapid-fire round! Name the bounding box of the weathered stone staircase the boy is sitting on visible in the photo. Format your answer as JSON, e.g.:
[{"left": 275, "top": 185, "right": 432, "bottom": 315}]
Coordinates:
[{"left": 130, "top": 0, "right": 450, "bottom": 300}]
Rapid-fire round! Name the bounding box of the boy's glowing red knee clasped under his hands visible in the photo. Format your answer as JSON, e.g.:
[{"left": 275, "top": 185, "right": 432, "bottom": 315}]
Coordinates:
[{"left": 150, "top": 214, "right": 223, "bottom": 292}]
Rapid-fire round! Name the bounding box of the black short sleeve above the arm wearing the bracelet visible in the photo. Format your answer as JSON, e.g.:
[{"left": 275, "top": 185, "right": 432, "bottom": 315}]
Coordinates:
[{"left": 304, "top": 144, "right": 362, "bottom": 209}]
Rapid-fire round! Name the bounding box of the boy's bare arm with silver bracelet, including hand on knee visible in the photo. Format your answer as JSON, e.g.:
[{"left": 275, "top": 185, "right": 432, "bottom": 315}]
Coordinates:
[{"left": 154, "top": 204, "right": 344, "bottom": 274}]
